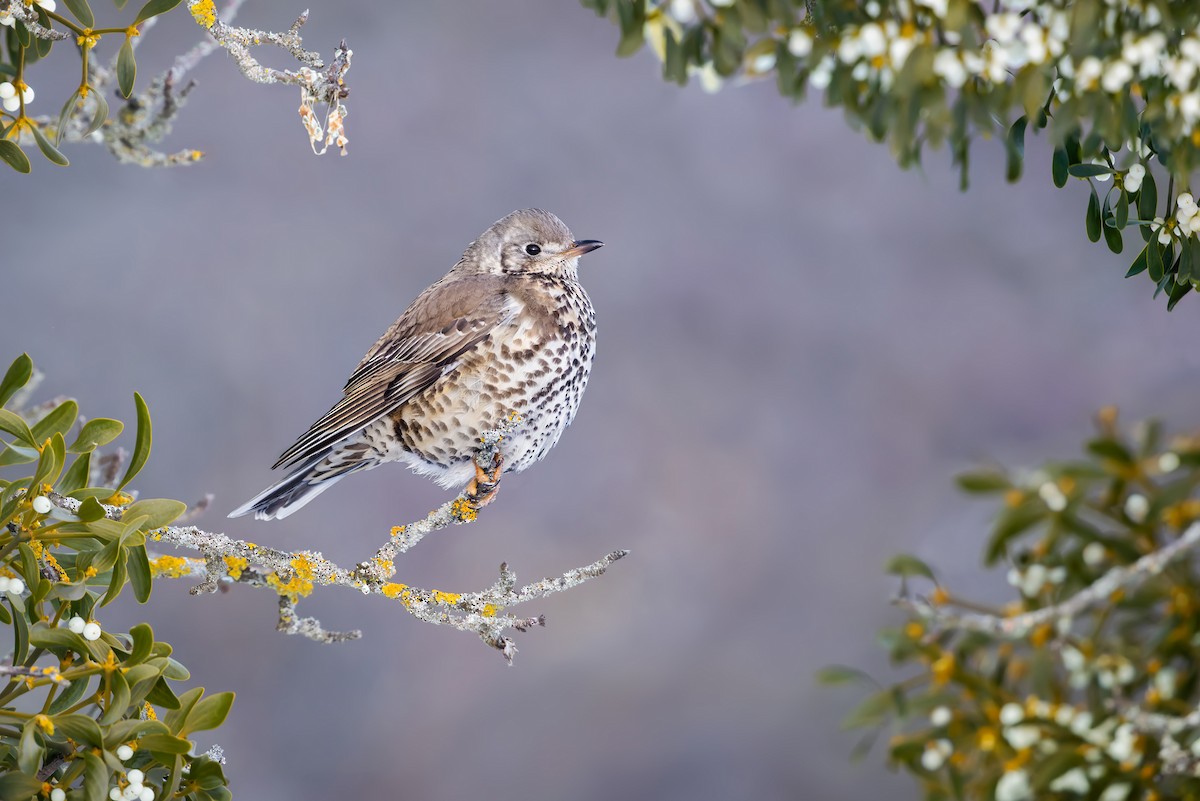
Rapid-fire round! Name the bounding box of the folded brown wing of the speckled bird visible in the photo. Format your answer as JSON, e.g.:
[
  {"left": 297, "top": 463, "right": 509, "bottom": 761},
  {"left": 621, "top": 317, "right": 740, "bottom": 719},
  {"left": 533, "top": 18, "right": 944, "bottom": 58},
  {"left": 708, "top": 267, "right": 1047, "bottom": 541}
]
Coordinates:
[{"left": 274, "top": 275, "right": 521, "bottom": 468}]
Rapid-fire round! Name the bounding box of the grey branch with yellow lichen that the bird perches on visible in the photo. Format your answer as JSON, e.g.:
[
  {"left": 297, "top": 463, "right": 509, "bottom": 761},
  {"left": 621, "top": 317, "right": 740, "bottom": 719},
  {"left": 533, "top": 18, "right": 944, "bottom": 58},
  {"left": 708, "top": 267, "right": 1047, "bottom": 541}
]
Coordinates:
[{"left": 49, "top": 428, "right": 629, "bottom": 663}]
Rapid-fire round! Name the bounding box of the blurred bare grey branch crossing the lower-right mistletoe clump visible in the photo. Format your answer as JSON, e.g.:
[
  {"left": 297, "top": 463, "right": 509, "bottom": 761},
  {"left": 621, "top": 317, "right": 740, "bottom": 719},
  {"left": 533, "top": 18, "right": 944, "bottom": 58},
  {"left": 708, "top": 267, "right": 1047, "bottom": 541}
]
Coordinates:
[{"left": 896, "top": 523, "right": 1200, "bottom": 639}]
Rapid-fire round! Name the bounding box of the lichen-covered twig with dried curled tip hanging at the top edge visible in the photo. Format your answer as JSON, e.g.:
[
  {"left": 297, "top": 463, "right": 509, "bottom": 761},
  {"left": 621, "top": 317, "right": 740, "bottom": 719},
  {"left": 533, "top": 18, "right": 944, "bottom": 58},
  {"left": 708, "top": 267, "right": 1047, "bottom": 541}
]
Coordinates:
[{"left": 187, "top": 0, "right": 354, "bottom": 156}]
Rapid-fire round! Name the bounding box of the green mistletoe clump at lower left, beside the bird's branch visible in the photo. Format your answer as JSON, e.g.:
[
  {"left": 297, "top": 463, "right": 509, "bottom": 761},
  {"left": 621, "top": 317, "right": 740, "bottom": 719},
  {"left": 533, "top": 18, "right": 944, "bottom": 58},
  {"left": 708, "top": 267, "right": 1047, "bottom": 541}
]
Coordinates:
[{"left": 0, "top": 356, "right": 233, "bottom": 801}]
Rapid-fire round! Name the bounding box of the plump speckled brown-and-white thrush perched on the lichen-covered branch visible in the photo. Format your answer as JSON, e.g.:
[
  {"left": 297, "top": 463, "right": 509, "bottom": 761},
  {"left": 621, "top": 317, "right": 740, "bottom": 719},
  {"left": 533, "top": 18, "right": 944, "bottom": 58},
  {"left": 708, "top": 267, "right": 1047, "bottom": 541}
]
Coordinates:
[{"left": 229, "top": 209, "right": 602, "bottom": 520}]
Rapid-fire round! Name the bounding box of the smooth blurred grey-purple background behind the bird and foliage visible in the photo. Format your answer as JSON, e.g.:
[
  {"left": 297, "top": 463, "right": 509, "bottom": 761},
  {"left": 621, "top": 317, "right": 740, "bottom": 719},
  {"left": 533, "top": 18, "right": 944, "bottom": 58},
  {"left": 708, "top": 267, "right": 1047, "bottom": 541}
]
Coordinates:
[{"left": 9, "top": 0, "right": 1200, "bottom": 801}]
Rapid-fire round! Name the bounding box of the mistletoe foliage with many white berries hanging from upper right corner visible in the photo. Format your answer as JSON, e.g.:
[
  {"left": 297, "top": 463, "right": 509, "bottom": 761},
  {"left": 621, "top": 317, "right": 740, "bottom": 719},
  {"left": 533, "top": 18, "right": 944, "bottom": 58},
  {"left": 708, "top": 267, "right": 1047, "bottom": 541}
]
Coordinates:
[{"left": 582, "top": 0, "right": 1200, "bottom": 308}]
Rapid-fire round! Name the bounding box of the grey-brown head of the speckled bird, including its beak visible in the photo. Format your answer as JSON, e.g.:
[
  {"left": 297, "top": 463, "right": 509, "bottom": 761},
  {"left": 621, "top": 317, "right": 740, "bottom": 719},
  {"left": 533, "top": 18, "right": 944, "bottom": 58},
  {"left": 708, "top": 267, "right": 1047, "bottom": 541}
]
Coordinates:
[{"left": 458, "top": 209, "right": 604, "bottom": 278}]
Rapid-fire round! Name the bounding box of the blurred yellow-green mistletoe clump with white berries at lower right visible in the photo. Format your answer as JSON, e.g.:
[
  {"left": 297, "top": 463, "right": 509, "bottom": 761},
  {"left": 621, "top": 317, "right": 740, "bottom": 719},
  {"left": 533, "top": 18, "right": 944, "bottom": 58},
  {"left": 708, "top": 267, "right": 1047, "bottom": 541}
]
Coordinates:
[{"left": 821, "top": 409, "right": 1200, "bottom": 801}]
